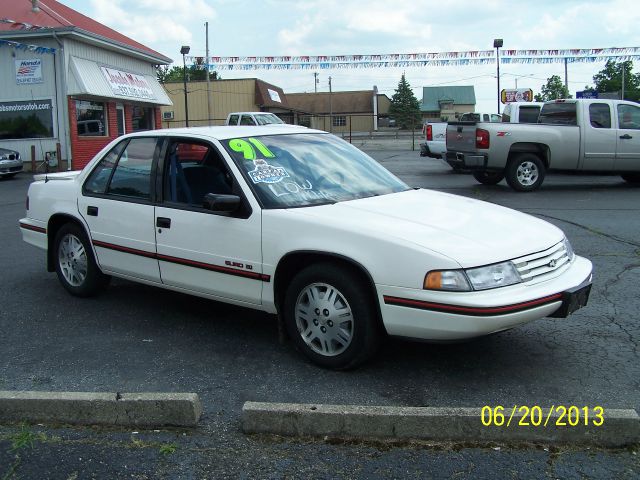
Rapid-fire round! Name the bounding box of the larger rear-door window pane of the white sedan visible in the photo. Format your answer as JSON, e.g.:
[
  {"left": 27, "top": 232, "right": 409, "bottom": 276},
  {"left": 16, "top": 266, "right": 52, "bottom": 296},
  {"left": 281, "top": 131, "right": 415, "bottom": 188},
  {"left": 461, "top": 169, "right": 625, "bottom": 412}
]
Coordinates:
[{"left": 107, "top": 137, "right": 157, "bottom": 200}]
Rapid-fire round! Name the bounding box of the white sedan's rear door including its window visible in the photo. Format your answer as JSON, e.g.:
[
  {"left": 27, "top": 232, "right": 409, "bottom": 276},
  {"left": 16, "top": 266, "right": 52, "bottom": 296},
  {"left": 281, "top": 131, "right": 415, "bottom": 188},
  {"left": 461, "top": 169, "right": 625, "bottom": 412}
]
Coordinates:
[{"left": 78, "top": 137, "right": 161, "bottom": 283}]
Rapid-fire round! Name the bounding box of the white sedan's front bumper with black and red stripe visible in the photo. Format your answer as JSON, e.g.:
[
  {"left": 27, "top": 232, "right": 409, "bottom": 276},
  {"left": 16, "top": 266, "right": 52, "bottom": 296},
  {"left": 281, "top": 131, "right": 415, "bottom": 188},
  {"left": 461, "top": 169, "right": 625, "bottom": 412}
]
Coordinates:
[{"left": 377, "top": 257, "right": 592, "bottom": 340}]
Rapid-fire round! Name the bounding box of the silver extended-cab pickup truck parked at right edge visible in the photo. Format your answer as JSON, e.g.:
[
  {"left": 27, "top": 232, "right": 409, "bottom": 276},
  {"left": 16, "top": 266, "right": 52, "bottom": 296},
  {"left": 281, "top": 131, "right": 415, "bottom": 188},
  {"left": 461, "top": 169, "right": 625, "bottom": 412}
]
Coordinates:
[{"left": 446, "top": 99, "right": 640, "bottom": 192}]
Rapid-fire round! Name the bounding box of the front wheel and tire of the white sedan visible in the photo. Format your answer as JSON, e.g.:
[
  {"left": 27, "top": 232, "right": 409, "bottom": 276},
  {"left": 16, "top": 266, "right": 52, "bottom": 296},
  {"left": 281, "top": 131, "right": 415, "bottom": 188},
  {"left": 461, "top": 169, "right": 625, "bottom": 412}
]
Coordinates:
[{"left": 283, "top": 263, "right": 382, "bottom": 370}]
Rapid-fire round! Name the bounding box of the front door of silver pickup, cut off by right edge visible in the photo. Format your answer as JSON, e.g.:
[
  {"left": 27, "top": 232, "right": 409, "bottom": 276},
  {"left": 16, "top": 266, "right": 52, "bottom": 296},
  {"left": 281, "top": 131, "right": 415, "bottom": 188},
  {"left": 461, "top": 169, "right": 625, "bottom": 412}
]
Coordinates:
[{"left": 614, "top": 104, "right": 640, "bottom": 172}]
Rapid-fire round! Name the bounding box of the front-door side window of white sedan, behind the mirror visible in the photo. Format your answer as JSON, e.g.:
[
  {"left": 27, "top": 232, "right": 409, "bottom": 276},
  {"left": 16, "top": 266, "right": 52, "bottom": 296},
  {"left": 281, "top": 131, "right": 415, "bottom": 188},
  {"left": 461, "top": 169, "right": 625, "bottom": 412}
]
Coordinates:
[{"left": 164, "top": 140, "right": 233, "bottom": 207}]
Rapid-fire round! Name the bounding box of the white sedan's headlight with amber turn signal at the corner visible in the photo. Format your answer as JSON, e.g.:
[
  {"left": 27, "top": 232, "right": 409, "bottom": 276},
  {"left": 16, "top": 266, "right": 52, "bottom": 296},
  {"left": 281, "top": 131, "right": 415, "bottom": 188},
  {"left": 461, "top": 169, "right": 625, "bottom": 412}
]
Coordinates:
[{"left": 423, "top": 262, "right": 522, "bottom": 292}]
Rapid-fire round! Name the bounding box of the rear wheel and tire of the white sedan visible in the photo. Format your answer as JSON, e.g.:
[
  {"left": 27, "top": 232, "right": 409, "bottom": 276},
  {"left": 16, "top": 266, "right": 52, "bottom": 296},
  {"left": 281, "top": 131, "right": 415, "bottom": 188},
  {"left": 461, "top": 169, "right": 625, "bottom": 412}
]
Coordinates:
[{"left": 53, "top": 223, "right": 111, "bottom": 297}]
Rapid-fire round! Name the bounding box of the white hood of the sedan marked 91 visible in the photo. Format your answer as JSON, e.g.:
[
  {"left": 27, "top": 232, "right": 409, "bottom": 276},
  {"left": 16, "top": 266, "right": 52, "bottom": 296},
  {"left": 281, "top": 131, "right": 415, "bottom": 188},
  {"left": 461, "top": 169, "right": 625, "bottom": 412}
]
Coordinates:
[{"left": 290, "top": 189, "right": 564, "bottom": 268}]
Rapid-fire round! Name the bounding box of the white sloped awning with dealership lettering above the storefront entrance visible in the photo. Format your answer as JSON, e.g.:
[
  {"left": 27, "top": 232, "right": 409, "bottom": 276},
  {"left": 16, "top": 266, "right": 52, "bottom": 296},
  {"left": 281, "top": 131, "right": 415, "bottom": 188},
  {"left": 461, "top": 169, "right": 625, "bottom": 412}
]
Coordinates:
[{"left": 67, "top": 57, "right": 173, "bottom": 105}]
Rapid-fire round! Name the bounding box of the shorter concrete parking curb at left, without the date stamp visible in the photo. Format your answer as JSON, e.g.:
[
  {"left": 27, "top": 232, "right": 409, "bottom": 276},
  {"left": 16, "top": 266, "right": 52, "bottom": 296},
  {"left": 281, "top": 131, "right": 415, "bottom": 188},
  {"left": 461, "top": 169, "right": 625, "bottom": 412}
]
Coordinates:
[{"left": 0, "top": 391, "right": 202, "bottom": 427}]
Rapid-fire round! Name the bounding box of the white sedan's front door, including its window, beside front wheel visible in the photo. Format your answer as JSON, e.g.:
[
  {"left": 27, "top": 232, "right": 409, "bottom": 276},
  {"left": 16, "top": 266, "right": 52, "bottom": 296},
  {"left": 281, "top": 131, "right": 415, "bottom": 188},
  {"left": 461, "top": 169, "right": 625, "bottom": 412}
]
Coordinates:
[{"left": 156, "top": 139, "right": 270, "bottom": 304}]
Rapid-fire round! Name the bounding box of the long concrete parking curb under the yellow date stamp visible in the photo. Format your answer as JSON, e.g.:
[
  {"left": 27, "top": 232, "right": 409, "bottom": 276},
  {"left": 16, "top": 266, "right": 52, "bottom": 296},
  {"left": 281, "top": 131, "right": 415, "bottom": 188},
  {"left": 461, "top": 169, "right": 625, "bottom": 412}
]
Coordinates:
[{"left": 242, "top": 402, "right": 640, "bottom": 447}]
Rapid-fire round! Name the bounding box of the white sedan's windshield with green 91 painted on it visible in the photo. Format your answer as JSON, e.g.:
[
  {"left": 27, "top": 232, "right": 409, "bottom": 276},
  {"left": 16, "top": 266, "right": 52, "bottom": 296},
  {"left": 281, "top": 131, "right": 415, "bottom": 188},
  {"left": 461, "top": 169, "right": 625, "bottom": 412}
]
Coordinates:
[{"left": 222, "top": 133, "right": 409, "bottom": 208}]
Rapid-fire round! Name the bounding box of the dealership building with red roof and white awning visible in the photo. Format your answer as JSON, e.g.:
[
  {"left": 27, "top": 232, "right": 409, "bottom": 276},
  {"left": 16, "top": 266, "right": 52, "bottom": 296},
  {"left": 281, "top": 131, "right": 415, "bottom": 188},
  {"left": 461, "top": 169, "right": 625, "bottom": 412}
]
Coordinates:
[{"left": 0, "top": 0, "right": 172, "bottom": 169}]
